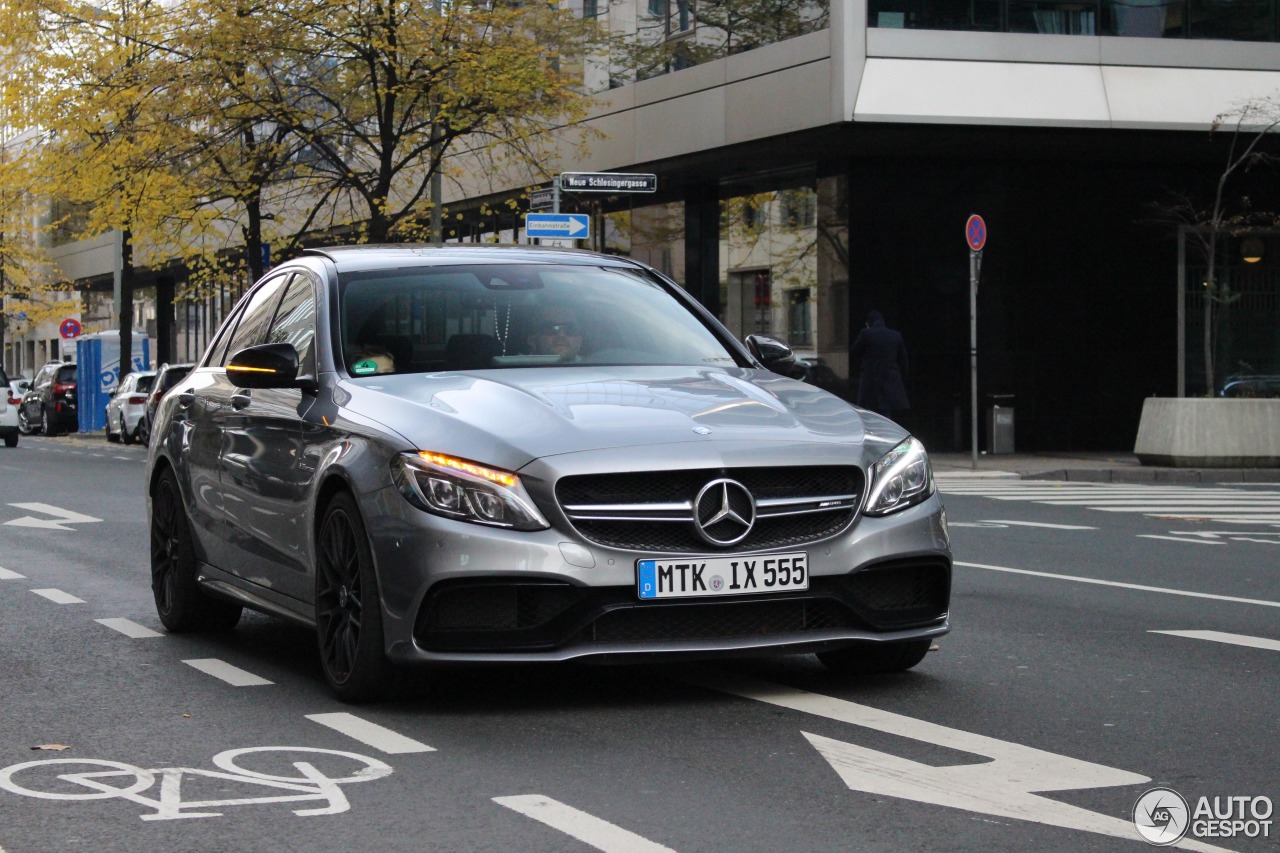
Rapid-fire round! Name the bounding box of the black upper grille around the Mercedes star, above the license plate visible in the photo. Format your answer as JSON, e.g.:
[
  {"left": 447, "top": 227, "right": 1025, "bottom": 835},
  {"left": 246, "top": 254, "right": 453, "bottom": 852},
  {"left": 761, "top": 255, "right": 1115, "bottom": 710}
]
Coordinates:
[{"left": 556, "top": 465, "right": 864, "bottom": 553}]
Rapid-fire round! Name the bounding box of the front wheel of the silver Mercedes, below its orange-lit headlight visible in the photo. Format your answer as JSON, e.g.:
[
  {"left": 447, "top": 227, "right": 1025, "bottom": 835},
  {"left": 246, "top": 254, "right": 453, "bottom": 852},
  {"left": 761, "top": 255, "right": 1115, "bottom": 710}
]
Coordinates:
[{"left": 316, "top": 492, "right": 396, "bottom": 702}]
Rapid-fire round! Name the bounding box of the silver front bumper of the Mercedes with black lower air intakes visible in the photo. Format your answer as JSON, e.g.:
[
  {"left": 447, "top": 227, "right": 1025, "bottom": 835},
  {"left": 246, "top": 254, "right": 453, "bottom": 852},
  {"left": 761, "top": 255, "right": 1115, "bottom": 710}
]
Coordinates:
[{"left": 364, "top": 488, "right": 951, "bottom": 663}]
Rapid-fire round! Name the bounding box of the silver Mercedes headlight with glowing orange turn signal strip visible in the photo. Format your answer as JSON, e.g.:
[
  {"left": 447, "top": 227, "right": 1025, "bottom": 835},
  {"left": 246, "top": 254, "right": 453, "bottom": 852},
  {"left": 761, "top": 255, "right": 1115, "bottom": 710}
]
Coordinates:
[{"left": 392, "top": 451, "right": 550, "bottom": 530}]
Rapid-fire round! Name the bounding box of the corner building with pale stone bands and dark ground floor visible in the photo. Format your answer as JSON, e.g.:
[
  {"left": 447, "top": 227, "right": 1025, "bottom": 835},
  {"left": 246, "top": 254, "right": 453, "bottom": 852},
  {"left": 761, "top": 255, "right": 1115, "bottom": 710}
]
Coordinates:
[{"left": 12, "top": 0, "right": 1280, "bottom": 450}]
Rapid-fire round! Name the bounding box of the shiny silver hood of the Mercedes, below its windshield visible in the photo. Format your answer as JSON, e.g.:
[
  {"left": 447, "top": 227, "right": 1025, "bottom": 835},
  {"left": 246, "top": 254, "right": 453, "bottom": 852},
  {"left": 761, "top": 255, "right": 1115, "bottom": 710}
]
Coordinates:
[{"left": 339, "top": 366, "right": 906, "bottom": 469}]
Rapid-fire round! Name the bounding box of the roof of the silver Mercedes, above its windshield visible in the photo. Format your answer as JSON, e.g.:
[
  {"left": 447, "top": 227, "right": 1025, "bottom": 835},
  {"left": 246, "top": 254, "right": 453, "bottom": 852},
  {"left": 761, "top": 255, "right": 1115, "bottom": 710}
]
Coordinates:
[{"left": 303, "top": 243, "right": 646, "bottom": 273}]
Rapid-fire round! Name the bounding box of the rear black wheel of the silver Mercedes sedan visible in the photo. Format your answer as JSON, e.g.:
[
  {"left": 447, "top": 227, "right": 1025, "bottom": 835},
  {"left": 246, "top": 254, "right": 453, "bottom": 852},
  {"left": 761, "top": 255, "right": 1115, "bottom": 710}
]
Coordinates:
[{"left": 151, "top": 469, "right": 242, "bottom": 634}]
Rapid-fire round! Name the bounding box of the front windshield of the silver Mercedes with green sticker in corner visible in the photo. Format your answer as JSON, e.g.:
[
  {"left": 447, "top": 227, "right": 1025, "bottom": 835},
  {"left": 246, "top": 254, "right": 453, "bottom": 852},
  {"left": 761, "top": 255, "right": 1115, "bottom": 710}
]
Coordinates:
[{"left": 340, "top": 264, "right": 737, "bottom": 377}]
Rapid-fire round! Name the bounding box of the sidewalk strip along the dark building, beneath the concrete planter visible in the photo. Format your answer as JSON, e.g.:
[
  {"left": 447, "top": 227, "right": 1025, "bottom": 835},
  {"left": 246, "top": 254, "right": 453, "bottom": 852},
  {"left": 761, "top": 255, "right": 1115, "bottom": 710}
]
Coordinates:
[{"left": 929, "top": 451, "right": 1280, "bottom": 483}]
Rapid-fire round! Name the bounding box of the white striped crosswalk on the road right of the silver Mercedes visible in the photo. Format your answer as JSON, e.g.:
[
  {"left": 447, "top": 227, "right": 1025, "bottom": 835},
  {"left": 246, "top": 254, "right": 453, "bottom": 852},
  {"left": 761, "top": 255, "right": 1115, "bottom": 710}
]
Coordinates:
[{"left": 938, "top": 476, "right": 1280, "bottom": 526}]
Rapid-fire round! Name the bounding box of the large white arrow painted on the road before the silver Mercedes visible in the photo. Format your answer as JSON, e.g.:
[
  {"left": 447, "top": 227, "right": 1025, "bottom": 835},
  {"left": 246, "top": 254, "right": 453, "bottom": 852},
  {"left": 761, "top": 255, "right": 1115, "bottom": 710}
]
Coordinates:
[{"left": 687, "top": 672, "right": 1222, "bottom": 850}]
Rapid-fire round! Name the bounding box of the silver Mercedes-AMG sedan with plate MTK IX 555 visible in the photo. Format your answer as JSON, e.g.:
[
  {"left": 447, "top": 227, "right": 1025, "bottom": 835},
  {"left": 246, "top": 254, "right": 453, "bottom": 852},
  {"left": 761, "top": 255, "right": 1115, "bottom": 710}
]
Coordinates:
[{"left": 147, "top": 246, "right": 951, "bottom": 702}]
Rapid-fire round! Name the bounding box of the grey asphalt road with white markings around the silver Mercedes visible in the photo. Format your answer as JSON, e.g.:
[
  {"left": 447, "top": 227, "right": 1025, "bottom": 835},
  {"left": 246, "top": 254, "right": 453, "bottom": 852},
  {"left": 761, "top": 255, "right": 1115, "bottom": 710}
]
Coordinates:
[{"left": 0, "top": 437, "right": 1280, "bottom": 853}]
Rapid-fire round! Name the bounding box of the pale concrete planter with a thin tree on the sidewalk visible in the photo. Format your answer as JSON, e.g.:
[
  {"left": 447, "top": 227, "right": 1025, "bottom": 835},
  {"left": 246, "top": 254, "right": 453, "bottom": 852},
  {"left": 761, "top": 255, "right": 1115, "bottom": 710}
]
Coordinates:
[{"left": 1133, "top": 397, "right": 1280, "bottom": 467}]
